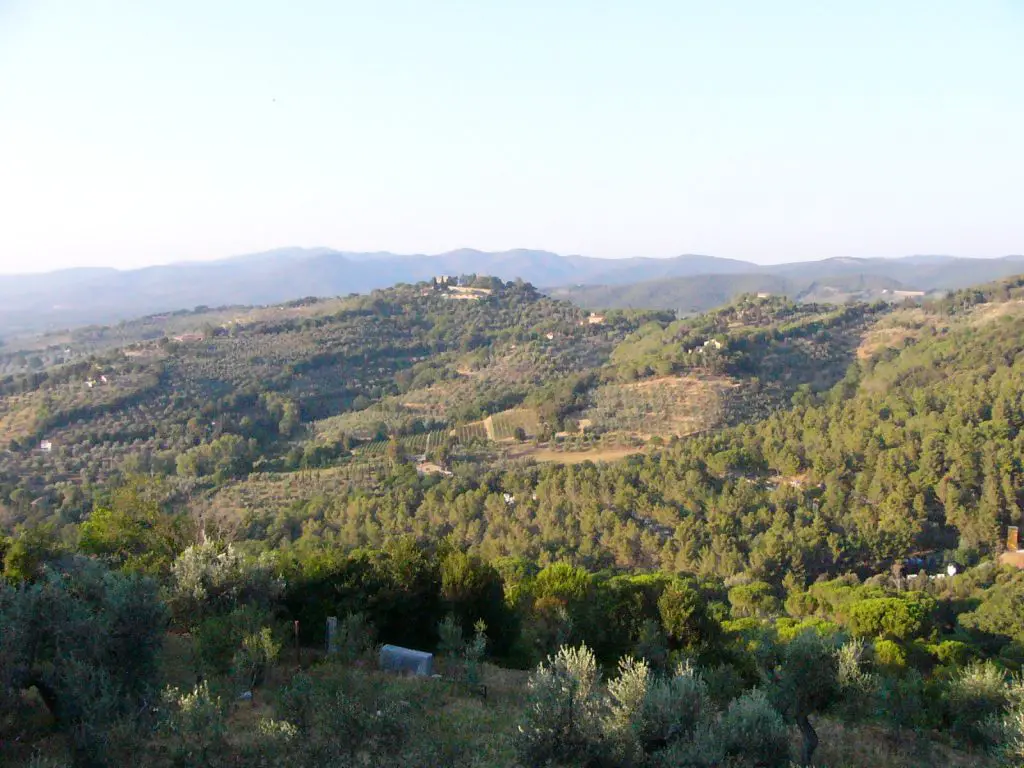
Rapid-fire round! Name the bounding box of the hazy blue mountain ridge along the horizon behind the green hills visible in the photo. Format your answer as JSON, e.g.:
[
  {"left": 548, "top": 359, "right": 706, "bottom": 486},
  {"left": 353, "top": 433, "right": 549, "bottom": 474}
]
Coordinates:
[{"left": 0, "top": 248, "right": 1024, "bottom": 335}]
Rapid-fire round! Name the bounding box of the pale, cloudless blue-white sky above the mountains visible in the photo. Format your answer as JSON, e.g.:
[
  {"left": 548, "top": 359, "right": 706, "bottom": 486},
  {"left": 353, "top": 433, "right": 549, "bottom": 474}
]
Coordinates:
[{"left": 0, "top": 0, "right": 1024, "bottom": 272}]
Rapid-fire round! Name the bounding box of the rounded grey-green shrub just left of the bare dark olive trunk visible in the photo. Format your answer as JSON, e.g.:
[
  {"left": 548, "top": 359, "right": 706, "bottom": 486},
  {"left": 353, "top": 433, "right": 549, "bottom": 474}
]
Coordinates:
[{"left": 721, "top": 689, "right": 790, "bottom": 768}]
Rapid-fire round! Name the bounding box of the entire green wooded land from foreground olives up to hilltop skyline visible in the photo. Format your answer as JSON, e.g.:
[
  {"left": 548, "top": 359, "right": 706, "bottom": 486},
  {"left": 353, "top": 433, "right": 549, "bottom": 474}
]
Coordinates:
[{"left": 6, "top": 279, "right": 1024, "bottom": 768}]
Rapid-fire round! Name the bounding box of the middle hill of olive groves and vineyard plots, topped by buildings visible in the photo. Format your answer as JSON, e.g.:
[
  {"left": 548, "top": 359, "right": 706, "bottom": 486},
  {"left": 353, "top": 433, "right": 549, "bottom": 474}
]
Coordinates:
[{"left": 0, "top": 278, "right": 876, "bottom": 524}]
